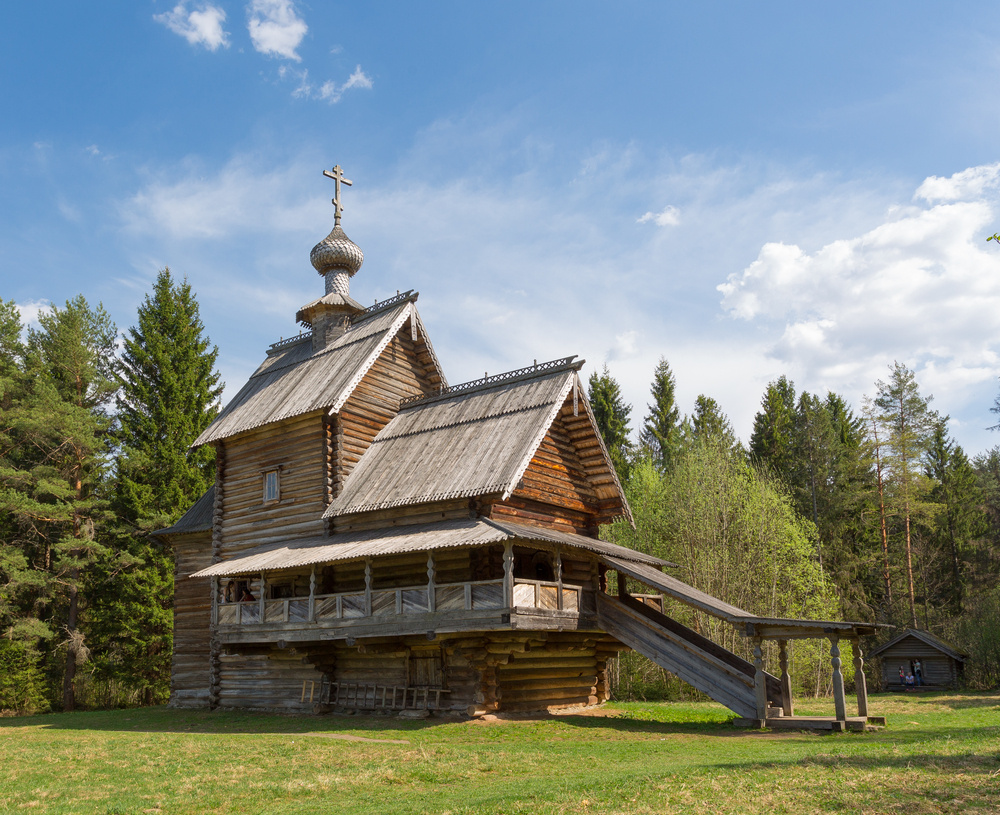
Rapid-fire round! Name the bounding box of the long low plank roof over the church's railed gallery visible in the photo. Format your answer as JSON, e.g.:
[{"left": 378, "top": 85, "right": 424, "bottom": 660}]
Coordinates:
[{"left": 191, "top": 518, "right": 673, "bottom": 577}]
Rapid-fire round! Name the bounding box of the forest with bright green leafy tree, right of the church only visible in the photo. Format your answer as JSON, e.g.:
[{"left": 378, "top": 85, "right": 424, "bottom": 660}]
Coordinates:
[{"left": 589, "top": 358, "right": 1000, "bottom": 693}]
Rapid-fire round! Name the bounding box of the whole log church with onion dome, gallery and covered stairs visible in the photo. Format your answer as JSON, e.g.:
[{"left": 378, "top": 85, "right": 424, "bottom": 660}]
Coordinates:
[{"left": 159, "top": 167, "right": 884, "bottom": 729}]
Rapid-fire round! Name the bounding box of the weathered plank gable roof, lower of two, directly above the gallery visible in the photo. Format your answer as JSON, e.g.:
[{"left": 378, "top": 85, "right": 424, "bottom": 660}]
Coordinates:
[{"left": 324, "top": 357, "right": 629, "bottom": 518}]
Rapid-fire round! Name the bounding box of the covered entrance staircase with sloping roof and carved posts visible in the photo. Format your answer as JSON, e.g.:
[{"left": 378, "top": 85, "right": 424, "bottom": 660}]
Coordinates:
[{"left": 597, "top": 555, "right": 882, "bottom": 730}]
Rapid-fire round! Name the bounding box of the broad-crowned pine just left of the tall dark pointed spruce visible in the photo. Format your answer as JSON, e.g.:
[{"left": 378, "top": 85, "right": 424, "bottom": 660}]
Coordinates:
[{"left": 2, "top": 297, "right": 117, "bottom": 710}]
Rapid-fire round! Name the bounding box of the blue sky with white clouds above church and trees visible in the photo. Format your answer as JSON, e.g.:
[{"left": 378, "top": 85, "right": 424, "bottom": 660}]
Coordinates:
[{"left": 0, "top": 0, "right": 1000, "bottom": 453}]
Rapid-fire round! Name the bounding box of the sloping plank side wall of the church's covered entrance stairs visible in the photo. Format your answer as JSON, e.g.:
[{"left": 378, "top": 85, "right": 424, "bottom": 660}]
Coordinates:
[{"left": 597, "top": 594, "right": 781, "bottom": 719}]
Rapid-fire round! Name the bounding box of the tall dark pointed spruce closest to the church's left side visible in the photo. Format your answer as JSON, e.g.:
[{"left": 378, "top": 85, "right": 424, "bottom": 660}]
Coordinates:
[{"left": 90, "top": 269, "right": 222, "bottom": 704}]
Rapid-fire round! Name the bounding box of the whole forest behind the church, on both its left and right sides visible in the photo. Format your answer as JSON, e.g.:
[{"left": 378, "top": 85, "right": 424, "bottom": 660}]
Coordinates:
[{"left": 0, "top": 269, "right": 1000, "bottom": 711}]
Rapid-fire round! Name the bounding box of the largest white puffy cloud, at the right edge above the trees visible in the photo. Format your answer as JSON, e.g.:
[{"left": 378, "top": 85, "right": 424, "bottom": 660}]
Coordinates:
[{"left": 718, "top": 165, "right": 1000, "bottom": 430}]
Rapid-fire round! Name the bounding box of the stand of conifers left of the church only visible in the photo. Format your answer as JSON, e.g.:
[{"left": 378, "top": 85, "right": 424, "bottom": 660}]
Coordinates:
[{"left": 0, "top": 269, "right": 222, "bottom": 711}]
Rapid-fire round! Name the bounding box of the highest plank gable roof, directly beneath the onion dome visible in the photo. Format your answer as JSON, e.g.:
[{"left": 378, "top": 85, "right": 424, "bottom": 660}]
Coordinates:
[{"left": 191, "top": 292, "right": 445, "bottom": 447}]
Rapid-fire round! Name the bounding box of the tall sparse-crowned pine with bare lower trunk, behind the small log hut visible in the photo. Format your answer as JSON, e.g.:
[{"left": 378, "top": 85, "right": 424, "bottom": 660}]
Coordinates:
[{"left": 874, "top": 362, "right": 938, "bottom": 628}]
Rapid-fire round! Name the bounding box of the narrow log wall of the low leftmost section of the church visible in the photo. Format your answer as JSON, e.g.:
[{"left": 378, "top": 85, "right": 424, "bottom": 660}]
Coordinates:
[{"left": 170, "top": 532, "right": 212, "bottom": 707}]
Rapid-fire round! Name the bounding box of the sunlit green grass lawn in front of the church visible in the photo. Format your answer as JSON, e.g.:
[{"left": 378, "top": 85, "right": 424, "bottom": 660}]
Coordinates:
[{"left": 0, "top": 693, "right": 1000, "bottom": 815}]
